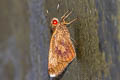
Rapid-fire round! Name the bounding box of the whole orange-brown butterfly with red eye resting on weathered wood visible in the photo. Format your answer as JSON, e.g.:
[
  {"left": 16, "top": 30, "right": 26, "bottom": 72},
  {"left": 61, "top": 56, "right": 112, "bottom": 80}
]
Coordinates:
[{"left": 48, "top": 11, "right": 77, "bottom": 77}]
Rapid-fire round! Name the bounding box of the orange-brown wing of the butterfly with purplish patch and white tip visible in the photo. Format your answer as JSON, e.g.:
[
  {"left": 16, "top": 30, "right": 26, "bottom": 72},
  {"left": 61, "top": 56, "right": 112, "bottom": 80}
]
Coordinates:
[{"left": 48, "top": 27, "right": 76, "bottom": 77}]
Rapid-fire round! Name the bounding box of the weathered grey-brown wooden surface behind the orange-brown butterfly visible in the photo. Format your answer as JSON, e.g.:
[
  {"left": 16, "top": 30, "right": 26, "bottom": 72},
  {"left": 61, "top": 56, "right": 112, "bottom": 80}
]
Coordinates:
[{"left": 0, "top": 0, "right": 120, "bottom": 80}]
